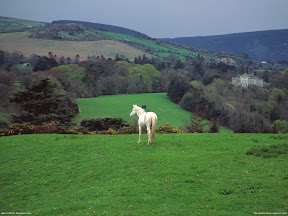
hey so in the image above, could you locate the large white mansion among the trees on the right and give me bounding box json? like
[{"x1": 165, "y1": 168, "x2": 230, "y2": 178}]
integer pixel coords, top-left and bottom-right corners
[{"x1": 232, "y1": 73, "x2": 269, "y2": 88}]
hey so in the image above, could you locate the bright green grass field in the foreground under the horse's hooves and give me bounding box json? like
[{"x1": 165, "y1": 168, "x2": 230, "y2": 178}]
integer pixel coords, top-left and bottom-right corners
[{"x1": 0, "y1": 133, "x2": 288, "y2": 216}]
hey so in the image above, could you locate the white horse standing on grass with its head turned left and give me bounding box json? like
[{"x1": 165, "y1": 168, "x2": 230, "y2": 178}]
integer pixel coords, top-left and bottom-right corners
[{"x1": 130, "y1": 104, "x2": 158, "y2": 145}]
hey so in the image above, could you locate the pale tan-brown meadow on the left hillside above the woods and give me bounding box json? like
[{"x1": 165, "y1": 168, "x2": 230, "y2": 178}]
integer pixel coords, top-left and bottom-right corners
[{"x1": 0, "y1": 32, "x2": 150, "y2": 60}]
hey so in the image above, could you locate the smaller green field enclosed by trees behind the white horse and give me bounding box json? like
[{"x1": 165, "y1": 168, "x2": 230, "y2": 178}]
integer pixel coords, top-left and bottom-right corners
[{"x1": 76, "y1": 93, "x2": 231, "y2": 132}]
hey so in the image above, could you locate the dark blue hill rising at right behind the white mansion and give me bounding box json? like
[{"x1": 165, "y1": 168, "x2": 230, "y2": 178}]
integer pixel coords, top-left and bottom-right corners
[{"x1": 160, "y1": 29, "x2": 288, "y2": 60}]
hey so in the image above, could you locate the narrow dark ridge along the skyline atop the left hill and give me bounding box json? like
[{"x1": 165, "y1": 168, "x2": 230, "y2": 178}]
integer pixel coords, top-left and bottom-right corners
[{"x1": 52, "y1": 20, "x2": 149, "y2": 38}]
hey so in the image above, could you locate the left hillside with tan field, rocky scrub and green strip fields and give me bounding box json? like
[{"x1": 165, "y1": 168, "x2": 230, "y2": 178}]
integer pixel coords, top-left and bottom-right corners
[{"x1": 0, "y1": 18, "x2": 202, "y2": 64}]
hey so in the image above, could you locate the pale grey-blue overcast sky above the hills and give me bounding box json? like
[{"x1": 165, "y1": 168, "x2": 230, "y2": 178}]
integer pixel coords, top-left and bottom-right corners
[{"x1": 0, "y1": 0, "x2": 288, "y2": 38}]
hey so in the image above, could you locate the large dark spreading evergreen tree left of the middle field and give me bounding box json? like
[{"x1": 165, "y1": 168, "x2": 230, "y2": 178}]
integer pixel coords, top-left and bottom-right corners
[{"x1": 10, "y1": 78, "x2": 78, "y2": 125}]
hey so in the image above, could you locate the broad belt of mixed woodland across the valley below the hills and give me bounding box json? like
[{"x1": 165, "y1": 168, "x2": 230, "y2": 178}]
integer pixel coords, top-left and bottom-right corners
[{"x1": 0, "y1": 51, "x2": 288, "y2": 133}]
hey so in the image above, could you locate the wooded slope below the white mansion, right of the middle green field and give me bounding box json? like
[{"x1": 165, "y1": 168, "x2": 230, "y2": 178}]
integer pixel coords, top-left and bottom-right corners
[{"x1": 167, "y1": 70, "x2": 288, "y2": 133}]
